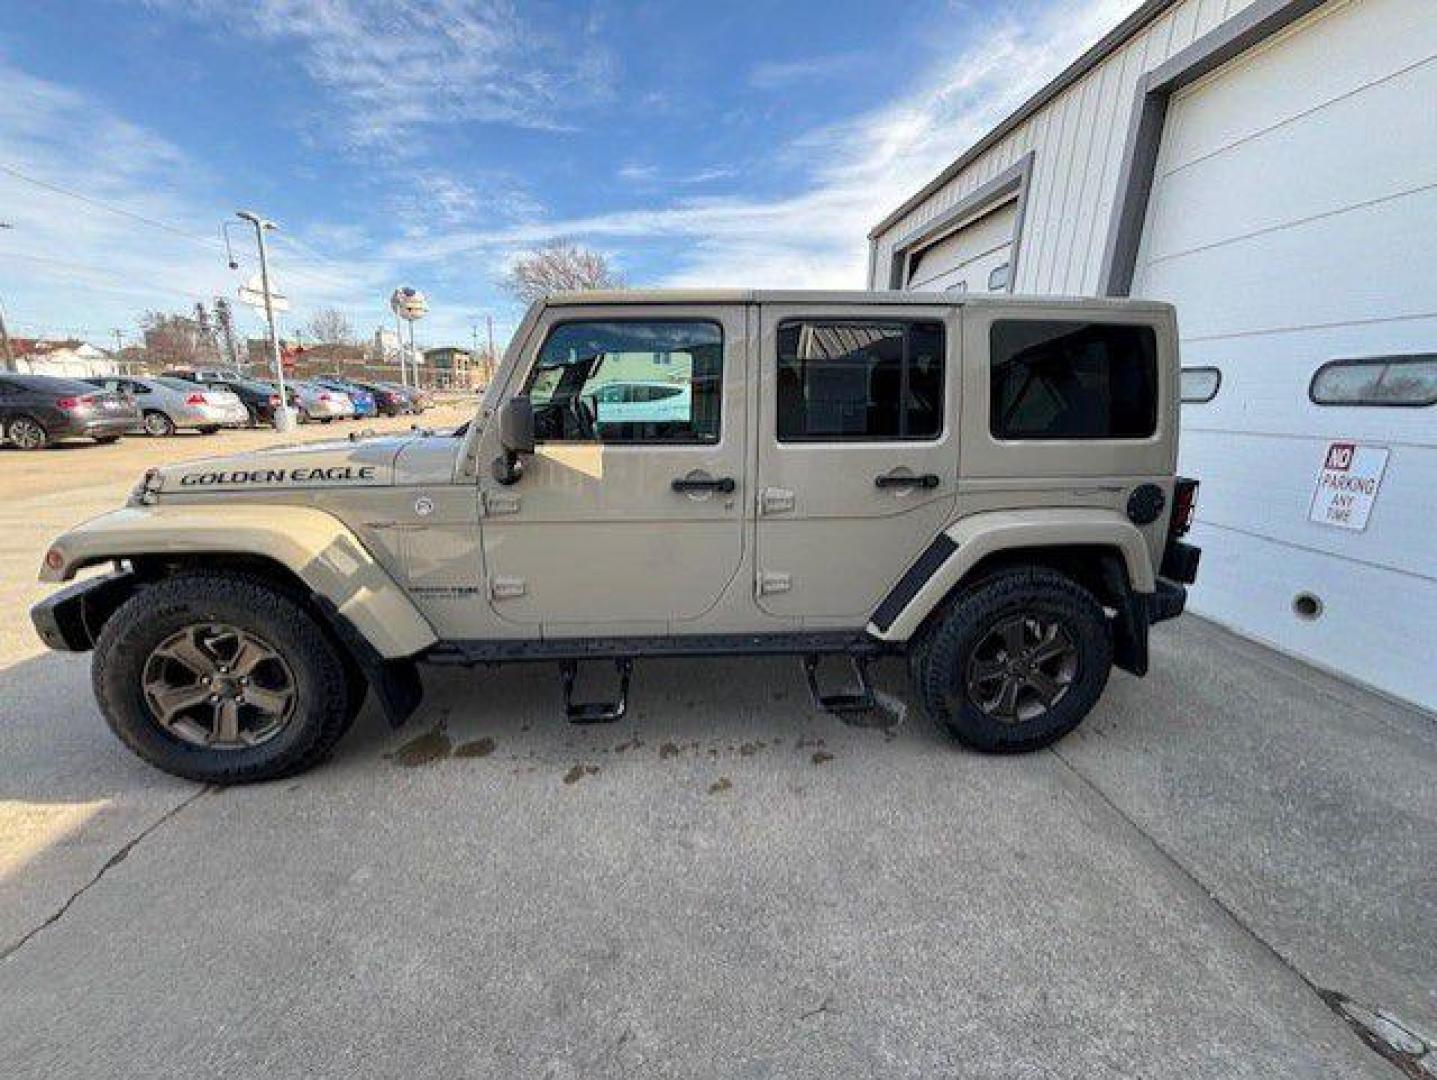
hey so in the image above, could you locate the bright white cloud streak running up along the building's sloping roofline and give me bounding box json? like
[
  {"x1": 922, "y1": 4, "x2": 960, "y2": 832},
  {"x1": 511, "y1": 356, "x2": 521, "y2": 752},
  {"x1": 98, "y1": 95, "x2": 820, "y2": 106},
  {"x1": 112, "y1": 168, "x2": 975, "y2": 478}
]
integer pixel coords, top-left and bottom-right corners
[{"x1": 387, "y1": 0, "x2": 1137, "y2": 289}]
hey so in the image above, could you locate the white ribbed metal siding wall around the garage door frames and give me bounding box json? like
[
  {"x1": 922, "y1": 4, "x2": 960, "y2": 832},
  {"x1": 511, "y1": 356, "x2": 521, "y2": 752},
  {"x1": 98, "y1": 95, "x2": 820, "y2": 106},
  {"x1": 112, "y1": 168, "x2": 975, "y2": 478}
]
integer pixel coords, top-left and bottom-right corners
[{"x1": 869, "y1": 0, "x2": 1252, "y2": 294}]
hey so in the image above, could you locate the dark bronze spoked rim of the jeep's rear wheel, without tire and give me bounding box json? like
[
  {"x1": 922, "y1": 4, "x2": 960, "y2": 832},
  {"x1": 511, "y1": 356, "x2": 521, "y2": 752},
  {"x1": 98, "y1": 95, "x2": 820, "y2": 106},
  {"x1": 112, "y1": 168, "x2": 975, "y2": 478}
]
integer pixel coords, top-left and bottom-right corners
[{"x1": 964, "y1": 615, "x2": 1078, "y2": 724}]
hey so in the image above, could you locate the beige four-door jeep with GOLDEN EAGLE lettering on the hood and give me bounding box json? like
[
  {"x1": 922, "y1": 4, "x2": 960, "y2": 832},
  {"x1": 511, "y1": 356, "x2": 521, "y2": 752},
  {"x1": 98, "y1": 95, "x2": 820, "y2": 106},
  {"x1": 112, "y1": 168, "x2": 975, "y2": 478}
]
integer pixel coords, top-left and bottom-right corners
[{"x1": 33, "y1": 292, "x2": 1198, "y2": 783}]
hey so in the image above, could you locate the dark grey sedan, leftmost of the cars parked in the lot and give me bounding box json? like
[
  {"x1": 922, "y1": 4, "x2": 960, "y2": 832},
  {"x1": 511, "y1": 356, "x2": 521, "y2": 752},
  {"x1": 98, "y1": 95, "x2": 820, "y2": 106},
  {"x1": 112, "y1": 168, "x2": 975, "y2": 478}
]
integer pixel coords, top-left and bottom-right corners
[{"x1": 0, "y1": 372, "x2": 139, "y2": 450}]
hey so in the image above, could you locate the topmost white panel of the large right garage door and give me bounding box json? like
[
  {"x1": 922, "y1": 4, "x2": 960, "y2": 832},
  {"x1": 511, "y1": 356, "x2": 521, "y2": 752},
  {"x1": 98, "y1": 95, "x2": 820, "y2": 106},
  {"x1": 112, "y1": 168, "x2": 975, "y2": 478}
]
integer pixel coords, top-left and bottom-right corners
[{"x1": 1158, "y1": 0, "x2": 1437, "y2": 171}]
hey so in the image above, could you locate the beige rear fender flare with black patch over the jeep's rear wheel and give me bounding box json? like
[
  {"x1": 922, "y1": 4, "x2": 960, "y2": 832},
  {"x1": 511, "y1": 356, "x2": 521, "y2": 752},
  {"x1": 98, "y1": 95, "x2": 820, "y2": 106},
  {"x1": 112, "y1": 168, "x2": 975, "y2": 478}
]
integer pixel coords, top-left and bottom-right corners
[{"x1": 868, "y1": 508, "x2": 1157, "y2": 642}]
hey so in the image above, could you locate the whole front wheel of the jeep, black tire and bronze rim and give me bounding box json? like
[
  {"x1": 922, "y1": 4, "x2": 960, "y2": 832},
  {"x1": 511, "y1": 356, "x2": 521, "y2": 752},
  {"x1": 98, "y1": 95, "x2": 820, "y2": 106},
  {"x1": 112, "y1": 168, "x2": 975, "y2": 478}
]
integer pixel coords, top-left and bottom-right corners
[{"x1": 92, "y1": 573, "x2": 354, "y2": 784}]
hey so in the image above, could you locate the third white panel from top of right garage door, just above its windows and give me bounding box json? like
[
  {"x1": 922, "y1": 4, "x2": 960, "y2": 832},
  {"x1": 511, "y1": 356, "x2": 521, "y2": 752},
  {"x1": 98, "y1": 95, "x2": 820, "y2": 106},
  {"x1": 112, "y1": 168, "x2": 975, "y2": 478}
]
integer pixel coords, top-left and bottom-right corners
[{"x1": 1134, "y1": 188, "x2": 1437, "y2": 339}]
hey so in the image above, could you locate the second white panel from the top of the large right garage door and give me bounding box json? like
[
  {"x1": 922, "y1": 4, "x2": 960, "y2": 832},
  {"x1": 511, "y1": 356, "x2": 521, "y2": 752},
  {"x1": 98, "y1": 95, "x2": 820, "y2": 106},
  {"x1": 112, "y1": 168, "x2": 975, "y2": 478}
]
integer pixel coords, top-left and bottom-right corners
[{"x1": 1148, "y1": 57, "x2": 1437, "y2": 260}]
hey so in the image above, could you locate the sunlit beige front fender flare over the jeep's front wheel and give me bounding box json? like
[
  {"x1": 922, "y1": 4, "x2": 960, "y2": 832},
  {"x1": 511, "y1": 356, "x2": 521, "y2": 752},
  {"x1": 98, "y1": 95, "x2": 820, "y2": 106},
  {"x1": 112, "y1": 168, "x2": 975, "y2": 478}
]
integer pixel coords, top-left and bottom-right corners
[{"x1": 40, "y1": 503, "x2": 438, "y2": 659}]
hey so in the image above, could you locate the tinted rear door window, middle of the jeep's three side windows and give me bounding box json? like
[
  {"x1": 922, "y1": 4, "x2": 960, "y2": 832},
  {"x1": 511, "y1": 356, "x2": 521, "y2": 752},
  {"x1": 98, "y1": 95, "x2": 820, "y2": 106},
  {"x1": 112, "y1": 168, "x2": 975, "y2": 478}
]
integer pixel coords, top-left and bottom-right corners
[{"x1": 777, "y1": 320, "x2": 944, "y2": 442}]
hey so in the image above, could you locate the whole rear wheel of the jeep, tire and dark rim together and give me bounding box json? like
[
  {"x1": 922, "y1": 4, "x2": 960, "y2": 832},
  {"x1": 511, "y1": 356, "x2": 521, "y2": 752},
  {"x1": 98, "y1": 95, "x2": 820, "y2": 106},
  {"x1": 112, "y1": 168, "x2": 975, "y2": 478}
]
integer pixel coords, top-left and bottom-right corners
[{"x1": 911, "y1": 567, "x2": 1112, "y2": 753}]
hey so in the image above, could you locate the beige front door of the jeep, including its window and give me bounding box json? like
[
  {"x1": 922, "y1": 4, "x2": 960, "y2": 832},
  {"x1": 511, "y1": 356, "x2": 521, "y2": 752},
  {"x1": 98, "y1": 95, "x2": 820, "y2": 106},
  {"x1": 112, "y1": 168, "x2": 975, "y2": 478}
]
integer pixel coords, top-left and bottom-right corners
[{"x1": 480, "y1": 304, "x2": 749, "y2": 638}]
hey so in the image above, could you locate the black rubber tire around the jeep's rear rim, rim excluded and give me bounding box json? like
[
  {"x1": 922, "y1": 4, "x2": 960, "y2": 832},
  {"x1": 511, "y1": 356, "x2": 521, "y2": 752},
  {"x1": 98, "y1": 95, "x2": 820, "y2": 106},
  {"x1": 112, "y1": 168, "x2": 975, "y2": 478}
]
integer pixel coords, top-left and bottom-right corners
[{"x1": 910, "y1": 567, "x2": 1112, "y2": 753}]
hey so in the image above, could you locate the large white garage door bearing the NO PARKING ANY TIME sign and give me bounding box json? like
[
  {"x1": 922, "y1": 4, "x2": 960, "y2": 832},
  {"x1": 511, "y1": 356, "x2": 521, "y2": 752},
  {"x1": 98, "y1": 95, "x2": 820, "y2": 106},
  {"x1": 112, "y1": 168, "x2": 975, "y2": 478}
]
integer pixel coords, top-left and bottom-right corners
[{"x1": 1132, "y1": 0, "x2": 1437, "y2": 708}]
